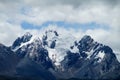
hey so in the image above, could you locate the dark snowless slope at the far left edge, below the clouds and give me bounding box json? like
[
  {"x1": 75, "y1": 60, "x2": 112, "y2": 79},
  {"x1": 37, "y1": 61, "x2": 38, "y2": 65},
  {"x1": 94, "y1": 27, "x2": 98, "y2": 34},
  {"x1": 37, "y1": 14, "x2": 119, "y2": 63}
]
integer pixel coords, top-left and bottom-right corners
[{"x1": 0, "y1": 44, "x2": 19, "y2": 75}]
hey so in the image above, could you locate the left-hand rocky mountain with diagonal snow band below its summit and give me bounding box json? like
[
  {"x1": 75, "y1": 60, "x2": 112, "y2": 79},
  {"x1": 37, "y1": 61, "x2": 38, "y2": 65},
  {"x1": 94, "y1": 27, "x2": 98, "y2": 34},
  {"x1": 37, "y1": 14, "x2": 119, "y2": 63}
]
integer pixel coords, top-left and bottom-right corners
[{"x1": 11, "y1": 33, "x2": 55, "y2": 80}]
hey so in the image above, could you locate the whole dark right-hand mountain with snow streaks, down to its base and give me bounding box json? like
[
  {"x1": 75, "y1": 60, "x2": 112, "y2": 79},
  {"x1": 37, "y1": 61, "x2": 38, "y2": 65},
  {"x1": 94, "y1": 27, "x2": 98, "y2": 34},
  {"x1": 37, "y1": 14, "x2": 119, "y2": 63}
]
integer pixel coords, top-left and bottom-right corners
[{"x1": 63, "y1": 35, "x2": 120, "y2": 79}]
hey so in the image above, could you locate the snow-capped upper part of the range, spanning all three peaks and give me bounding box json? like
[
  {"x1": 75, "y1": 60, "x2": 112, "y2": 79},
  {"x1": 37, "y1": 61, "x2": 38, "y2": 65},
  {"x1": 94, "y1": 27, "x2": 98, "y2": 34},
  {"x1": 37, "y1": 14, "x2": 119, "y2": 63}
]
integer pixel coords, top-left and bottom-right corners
[{"x1": 10, "y1": 30, "x2": 119, "y2": 72}]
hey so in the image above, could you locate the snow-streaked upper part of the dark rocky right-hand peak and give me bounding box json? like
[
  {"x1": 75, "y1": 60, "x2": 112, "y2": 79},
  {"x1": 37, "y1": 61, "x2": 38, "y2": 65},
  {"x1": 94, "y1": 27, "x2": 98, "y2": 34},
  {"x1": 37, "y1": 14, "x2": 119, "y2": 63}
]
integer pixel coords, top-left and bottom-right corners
[{"x1": 67, "y1": 35, "x2": 105, "y2": 62}]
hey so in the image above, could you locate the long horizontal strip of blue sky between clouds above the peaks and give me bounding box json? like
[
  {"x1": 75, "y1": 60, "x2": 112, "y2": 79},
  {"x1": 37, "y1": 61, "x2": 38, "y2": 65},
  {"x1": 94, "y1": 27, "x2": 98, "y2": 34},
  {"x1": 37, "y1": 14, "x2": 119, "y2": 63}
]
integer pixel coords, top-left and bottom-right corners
[{"x1": 21, "y1": 21, "x2": 108, "y2": 30}]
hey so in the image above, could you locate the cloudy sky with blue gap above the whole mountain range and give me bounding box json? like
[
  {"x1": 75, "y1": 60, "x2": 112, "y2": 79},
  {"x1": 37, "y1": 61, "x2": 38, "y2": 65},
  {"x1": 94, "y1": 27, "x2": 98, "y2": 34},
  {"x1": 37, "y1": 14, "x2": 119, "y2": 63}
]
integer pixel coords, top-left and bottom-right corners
[{"x1": 0, "y1": 0, "x2": 120, "y2": 60}]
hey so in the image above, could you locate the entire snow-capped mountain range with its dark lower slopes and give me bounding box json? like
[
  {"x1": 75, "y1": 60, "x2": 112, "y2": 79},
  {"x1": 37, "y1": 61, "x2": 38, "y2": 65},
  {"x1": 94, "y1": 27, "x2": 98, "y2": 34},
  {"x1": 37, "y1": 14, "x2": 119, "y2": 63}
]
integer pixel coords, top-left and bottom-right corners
[{"x1": 0, "y1": 30, "x2": 120, "y2": 80}]
